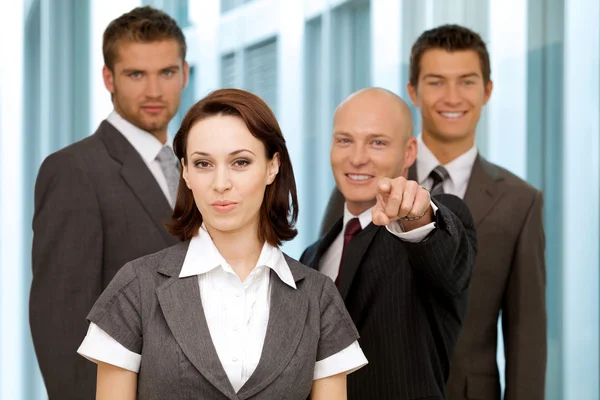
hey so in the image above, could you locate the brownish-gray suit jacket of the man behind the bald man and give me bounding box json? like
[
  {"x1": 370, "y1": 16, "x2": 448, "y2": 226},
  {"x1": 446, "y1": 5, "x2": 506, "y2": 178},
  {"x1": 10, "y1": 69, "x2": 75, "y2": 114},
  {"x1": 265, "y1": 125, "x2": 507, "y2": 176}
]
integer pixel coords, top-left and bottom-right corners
[{"x1": 322, "y1": 156, "x2": 547, "y2": 400}]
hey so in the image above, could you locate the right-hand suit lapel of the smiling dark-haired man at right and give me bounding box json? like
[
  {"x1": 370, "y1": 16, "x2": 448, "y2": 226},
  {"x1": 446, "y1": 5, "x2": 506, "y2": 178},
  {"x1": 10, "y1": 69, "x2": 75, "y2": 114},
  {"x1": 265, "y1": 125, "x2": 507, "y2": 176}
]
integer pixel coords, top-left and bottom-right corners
[{"x1": 464, "y1": 155, "x2": 502, "y2": 227}]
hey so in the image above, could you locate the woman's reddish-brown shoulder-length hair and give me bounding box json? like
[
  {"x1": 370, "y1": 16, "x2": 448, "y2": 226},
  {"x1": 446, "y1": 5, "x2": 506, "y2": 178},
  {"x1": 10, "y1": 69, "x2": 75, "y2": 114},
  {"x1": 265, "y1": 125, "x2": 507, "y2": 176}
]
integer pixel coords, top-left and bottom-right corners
[{"x1": 167, "y1": 89, "x2": 298, "y2": 246}]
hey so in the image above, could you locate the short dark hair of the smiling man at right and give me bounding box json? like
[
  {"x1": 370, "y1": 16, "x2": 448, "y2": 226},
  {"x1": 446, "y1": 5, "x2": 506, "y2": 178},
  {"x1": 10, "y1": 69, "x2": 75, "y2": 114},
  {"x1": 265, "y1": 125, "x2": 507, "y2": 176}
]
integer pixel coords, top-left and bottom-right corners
[{"x1": 409, "y1": 25, "x2": 491, "y2": 87}]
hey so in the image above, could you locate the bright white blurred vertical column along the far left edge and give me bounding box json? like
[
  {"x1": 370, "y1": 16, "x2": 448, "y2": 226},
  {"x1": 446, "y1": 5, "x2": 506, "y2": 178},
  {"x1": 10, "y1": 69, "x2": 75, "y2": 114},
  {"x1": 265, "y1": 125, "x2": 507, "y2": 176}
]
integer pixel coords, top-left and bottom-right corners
[{"x1": 0, "y1": 1, "x2": 29, "y2": 399}]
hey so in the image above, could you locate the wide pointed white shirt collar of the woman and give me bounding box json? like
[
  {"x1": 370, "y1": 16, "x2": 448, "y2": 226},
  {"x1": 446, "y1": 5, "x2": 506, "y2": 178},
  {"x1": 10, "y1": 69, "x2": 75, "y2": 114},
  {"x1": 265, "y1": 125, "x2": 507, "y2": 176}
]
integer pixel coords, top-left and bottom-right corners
[{"x1": 179, "y1": 224, "x2": 296, "y2": 289}]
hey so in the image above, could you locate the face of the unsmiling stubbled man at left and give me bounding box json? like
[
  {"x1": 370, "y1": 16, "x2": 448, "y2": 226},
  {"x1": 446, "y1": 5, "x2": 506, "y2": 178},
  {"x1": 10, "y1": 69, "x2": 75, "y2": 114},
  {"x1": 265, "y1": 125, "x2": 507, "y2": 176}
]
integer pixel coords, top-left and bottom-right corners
[{"x1": 102, "y1": 39, "x2": 189, "y2": 143}]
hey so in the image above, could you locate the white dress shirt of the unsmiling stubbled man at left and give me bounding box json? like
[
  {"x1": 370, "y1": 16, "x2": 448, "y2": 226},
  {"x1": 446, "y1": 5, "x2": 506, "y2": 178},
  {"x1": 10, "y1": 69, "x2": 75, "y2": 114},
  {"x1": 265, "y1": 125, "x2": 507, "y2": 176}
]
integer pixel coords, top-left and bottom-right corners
[{"x1": 106, "y1": 111, "x2": 175, "y2": 207}]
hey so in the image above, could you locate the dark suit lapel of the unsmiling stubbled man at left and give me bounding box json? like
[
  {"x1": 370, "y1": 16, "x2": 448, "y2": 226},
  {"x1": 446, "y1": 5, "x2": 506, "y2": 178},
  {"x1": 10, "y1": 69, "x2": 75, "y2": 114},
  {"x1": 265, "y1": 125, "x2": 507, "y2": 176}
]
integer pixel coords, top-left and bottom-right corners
[{"x1": 98, "y1": 121, "x2": 176, "y2": 244}]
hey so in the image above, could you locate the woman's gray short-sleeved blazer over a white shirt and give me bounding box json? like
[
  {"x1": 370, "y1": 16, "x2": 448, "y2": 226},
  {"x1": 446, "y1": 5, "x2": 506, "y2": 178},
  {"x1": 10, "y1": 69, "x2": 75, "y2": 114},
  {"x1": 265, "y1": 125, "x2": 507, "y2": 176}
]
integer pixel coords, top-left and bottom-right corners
[{"x1": 88, "y1": 241, "x2": 358, "y2": 400}]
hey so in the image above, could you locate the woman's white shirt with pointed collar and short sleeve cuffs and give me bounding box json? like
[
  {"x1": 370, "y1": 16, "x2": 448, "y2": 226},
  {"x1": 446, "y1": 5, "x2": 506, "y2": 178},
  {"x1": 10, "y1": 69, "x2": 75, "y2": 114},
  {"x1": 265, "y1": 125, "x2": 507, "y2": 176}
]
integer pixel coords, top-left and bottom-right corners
[{"x1": 77, "y1": 227, "x2": 367, "y2": 392}]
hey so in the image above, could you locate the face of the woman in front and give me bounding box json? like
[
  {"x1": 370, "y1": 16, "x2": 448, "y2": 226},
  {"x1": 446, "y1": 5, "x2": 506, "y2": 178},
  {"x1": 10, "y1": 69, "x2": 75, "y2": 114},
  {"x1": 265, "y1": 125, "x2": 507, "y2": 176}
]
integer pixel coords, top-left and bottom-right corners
[{"x1": 182, "y1": 115, "x2": 279, "y2": 233}]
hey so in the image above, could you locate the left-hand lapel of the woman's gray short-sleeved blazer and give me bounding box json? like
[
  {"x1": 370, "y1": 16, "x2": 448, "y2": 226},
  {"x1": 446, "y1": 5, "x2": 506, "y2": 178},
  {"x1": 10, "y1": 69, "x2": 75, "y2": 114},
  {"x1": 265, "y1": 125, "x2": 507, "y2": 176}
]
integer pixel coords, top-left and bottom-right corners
[{"x1": 156, "y1": 242, "x2": 237, "y2": 399}]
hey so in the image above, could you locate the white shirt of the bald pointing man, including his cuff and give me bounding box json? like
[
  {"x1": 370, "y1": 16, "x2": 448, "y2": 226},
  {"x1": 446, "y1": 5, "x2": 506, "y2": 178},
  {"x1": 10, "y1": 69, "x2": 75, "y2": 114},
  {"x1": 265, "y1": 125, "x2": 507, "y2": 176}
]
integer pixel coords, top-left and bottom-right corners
[{"x1": 319, "y1": 202, "x2": 438, "y2": 282}]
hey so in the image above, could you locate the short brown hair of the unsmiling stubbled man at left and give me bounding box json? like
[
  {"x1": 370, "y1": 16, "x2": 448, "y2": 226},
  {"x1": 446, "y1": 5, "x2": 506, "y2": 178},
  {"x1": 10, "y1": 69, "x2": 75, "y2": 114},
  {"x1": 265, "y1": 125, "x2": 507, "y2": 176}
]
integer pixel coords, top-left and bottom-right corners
[{"x1": 102, "y1": 6, "x2": 187, "y2": 72}]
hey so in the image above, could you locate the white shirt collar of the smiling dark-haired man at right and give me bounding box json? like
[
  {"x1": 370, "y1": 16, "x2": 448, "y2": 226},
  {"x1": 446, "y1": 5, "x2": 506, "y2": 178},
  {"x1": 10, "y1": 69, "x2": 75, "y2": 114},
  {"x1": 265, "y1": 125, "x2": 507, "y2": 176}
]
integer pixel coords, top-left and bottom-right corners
[{"x1": 417, "y1": 135, "x2": 477, "y2": 185}]
